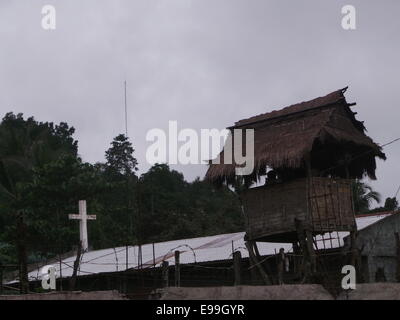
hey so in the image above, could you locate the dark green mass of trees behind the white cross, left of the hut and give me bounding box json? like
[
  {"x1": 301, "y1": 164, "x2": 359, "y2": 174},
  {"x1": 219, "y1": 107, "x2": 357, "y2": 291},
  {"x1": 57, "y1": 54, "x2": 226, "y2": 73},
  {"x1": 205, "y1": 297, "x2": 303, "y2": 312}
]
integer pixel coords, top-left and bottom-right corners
[{"x1": 0, "y1": 113, "x2": 243, "y2": 274}]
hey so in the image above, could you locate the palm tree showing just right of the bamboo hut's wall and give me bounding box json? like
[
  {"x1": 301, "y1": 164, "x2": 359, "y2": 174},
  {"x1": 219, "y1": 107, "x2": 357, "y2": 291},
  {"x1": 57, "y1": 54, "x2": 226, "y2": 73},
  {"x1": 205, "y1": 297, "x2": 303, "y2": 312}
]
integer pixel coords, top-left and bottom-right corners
[{"x1": 352, "y1": 180, "x2": 381, "y2": 214}]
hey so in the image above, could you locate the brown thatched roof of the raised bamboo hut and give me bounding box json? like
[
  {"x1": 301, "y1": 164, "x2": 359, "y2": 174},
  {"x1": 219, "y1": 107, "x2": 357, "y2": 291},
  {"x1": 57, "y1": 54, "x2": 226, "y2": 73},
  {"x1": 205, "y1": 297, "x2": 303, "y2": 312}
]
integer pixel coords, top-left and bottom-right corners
[{"x1": 206, "y1": 87, "x2": 385, "y2": 182}]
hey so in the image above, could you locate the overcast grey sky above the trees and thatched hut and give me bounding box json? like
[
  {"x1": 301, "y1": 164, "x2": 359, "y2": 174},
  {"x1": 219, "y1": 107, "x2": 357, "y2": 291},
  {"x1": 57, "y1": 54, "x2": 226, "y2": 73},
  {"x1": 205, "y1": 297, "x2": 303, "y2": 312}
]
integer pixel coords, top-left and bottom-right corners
[{"x1": 0, "y1": 0, "x2": 400, "y2": 202}]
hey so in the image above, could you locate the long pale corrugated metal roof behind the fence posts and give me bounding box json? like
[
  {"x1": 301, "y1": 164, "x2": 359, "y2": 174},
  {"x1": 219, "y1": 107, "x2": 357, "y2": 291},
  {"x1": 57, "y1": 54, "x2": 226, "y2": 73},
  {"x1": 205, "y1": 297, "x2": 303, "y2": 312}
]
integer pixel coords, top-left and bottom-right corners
[{"x1": 18, "y1": 213, "x2": 391, "y2": 280}]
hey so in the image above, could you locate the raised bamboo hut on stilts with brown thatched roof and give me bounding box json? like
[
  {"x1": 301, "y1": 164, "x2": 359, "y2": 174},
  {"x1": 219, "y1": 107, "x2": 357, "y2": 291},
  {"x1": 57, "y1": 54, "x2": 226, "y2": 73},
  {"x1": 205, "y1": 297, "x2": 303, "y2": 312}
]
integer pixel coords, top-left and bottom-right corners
[{"x1": 206, "y1": 87, "x2": 385, "y2": 282}]
